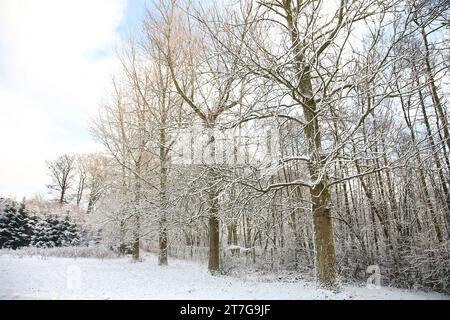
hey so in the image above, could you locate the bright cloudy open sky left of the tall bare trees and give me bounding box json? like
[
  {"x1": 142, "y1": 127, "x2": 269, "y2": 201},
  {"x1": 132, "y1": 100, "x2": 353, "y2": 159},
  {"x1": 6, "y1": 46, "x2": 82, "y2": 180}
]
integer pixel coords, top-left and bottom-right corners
[{"x1": 0, "y1": 0, "x2": 145, "y2": 199}]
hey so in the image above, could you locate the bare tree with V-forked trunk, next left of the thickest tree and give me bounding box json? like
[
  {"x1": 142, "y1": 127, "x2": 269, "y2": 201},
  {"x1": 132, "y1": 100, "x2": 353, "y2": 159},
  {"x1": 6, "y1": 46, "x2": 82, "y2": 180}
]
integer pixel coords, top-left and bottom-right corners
[{"x1": 145, "y1": 2, "x2": 250, "y2": 272}]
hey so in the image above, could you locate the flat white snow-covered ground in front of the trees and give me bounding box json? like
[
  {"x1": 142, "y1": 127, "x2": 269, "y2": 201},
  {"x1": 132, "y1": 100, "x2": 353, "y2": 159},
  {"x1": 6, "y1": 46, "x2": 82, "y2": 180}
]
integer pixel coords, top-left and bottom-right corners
[{"x1": 0, "y1": 253, "x2": 450, "y2": 300}]
